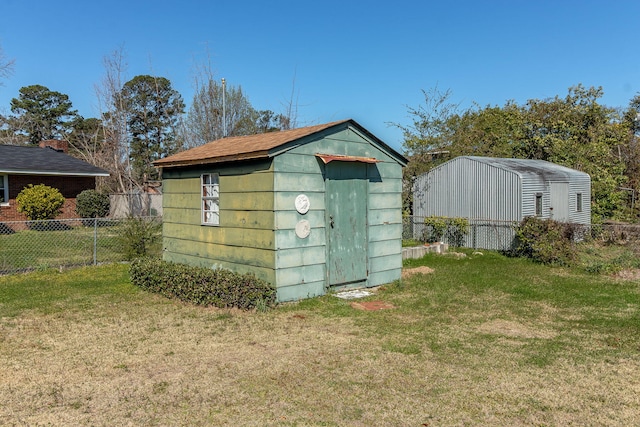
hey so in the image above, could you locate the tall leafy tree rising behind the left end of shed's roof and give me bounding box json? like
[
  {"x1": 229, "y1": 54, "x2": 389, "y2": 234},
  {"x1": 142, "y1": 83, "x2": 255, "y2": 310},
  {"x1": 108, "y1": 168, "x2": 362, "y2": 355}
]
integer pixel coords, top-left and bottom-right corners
[{"x1": 122, "y1": 75, "x2": 185, "y2": 184}]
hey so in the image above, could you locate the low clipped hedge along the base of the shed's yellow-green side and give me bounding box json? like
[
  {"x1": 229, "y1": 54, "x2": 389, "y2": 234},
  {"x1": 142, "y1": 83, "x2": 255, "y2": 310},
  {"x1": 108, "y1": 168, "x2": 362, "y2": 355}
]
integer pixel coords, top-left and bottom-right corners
[{"x1": 130, "y1": 258, "x2": 276, "y2": 310}]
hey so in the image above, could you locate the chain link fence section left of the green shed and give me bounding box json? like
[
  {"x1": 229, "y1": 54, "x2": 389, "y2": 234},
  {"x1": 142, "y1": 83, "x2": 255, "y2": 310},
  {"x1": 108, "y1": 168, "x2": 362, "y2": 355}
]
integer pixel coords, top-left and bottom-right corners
[{"x1": 0, "y1": 217, "x2": 162, "y2": 274}]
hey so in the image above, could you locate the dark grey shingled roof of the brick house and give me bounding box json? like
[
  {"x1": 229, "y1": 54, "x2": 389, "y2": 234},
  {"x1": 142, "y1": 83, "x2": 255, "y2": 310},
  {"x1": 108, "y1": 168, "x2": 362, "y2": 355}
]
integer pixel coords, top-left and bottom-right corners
[{"x1": 0, "y1": 145, "x2": 109, "y2": 176}]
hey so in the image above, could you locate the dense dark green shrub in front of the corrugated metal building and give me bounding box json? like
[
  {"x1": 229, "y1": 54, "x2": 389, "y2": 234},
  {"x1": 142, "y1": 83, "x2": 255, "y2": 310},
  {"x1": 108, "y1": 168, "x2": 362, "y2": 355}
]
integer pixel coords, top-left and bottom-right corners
[{"x1": 512, "y1": 217, "x2": 577, "y2": 265}]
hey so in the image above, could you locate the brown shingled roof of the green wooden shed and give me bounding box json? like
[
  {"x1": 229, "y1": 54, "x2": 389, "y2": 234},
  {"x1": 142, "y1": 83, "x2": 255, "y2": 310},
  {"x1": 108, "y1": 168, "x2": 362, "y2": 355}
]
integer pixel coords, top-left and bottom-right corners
[{"x1": 153, "y1": 119, "x2": 407, "y2": 167}]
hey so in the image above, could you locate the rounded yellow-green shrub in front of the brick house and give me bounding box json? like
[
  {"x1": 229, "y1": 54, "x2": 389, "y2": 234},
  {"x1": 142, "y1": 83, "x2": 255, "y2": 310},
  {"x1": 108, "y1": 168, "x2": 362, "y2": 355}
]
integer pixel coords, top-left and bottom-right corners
[{"x1": 16, "y1": 184, "x2": 64, "y2": 221}]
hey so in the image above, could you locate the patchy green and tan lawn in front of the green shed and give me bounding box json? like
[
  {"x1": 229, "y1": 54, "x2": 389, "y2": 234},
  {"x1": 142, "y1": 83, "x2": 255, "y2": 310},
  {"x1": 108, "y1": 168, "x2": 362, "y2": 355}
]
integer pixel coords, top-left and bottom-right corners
[{"x1": 0, "y1": 252, "x2": 640, "y2": 426}]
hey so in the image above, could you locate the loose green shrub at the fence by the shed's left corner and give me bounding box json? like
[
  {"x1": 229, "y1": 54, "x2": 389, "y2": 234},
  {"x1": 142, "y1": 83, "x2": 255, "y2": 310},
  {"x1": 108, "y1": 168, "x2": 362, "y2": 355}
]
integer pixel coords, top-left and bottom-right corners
[{"x1": 118, "y1": 217, "x2": 162, "y2": 261}]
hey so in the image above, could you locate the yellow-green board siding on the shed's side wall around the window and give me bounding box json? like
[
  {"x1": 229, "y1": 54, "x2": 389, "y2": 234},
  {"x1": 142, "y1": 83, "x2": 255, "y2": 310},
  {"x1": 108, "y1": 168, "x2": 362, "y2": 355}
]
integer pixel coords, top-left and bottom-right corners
[{"x1": 163, "y1": 161, "x2": 276, "y2": 283}]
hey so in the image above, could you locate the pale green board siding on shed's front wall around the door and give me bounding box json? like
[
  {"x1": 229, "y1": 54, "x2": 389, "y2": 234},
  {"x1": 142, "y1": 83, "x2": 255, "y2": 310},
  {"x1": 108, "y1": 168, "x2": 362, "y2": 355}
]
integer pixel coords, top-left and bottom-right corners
[{"x1": 273, "y1": 128, "x2": 402, "y2": 300}]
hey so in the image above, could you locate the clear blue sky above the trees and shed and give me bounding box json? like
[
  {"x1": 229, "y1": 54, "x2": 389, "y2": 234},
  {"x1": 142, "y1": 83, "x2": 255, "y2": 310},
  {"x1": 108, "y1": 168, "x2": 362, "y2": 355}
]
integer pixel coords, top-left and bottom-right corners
[{"x1": 0, "y1": 0, "x2": 640, "y2": 154}]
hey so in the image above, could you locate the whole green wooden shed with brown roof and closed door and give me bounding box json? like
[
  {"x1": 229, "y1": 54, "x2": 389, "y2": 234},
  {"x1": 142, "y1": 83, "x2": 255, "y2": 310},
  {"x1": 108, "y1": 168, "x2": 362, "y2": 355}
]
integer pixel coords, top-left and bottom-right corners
[{"x1": 154, "y1": 120, "x2": 407, "y2": 301}]
